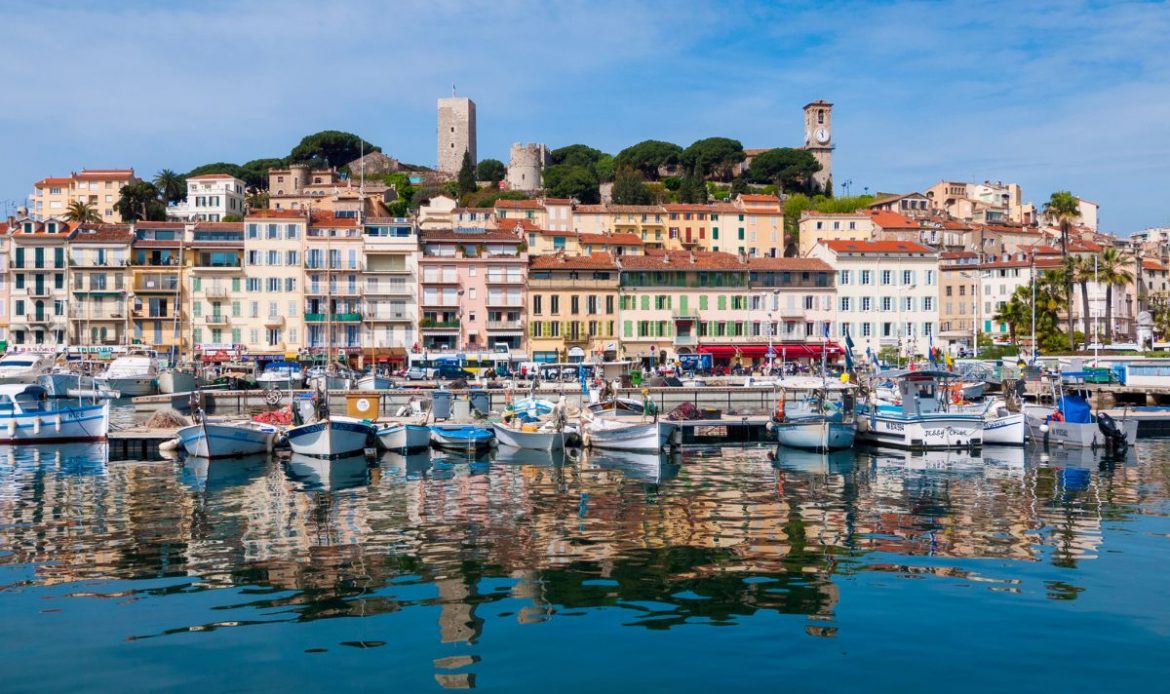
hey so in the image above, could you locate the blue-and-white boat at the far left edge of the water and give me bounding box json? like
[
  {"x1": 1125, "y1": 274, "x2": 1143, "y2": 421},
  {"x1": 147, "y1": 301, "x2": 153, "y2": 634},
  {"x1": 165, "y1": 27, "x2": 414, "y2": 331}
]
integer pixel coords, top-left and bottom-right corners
[{"x1": 0, "y1": 383, "x2": 110, "y2": 444}]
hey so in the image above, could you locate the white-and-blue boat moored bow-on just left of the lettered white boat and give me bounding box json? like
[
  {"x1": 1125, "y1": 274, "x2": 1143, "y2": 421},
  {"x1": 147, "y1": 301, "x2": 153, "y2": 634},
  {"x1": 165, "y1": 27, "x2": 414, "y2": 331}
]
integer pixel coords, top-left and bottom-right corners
[{"x1": 771, "y1": 378, "x2": 858, "y2": 451}]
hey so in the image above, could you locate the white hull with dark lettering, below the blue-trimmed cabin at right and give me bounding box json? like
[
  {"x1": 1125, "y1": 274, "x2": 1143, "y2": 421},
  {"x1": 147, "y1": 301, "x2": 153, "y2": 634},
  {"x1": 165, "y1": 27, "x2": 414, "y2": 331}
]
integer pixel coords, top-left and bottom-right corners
[{"x1": 858, "y1": 412, "x2": 983, "y2": 451}]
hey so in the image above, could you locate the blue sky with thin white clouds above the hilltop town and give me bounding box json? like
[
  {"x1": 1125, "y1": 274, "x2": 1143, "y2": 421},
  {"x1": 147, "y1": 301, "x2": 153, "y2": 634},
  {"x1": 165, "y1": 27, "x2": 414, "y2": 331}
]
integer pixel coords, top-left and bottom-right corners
[{"x1": 0, "y1": 0, "x2": 1170, "y2": 234}]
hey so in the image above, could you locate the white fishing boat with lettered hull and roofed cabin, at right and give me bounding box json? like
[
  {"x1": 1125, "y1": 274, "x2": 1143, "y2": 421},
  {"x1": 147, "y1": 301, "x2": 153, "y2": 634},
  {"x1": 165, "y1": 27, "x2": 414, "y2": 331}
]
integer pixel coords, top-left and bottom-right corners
[{"x1": 858, "y1": 370, "x2": 983, "y2": 451}]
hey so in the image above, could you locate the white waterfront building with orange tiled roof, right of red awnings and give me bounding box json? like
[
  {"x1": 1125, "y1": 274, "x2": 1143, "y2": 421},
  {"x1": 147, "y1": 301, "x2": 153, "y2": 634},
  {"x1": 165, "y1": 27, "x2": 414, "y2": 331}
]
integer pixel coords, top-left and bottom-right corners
[{"x1": 810, "y1": 241, "x2": 938, "y2": 356}]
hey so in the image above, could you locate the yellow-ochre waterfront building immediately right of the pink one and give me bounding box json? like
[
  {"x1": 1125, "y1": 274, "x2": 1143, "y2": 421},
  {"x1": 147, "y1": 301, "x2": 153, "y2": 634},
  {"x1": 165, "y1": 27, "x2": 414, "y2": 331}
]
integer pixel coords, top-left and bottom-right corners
[{"x1": 528, "y1": 253, "x2": 618, "y2": 362}]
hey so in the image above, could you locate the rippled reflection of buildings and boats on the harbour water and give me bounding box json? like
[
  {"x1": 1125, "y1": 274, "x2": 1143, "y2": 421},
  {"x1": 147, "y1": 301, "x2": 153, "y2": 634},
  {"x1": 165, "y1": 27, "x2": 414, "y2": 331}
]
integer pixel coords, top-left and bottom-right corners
[{"x1": 0, "y1": 442, "x2": 1170, "y2": 664}]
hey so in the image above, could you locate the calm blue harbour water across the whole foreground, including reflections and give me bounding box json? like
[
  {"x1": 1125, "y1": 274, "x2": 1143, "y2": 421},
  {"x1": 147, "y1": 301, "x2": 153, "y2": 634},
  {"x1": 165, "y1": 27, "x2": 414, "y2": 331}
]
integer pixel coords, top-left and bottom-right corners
[{"x1": 0, "y1": 440, "x2": 1170, "y2": 693}]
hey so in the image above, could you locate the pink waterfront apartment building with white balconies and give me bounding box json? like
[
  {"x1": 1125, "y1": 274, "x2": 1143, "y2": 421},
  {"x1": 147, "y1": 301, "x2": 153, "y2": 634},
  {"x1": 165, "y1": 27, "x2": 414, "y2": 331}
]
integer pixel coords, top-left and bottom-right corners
[{"x1": 419, "y1": 229, "x2": 528, "y2": 353}]
